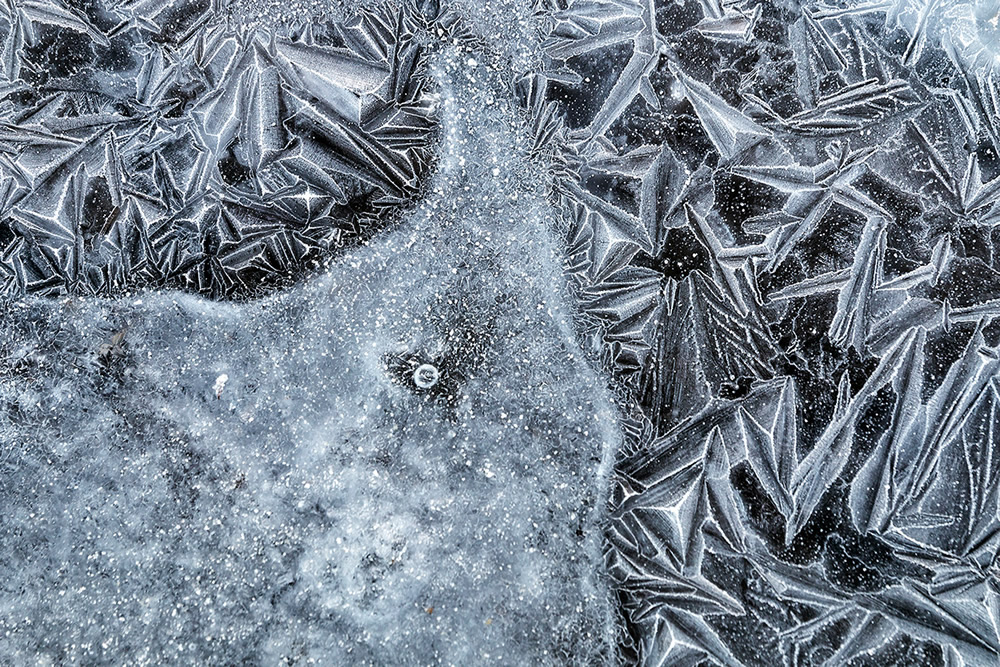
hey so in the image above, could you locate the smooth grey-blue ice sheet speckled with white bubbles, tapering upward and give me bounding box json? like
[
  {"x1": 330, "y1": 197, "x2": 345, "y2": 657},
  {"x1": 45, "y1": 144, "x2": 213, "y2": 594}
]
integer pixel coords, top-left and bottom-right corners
[{"x1": 0, "y1": 49, "x2": 618, "y2": 665}]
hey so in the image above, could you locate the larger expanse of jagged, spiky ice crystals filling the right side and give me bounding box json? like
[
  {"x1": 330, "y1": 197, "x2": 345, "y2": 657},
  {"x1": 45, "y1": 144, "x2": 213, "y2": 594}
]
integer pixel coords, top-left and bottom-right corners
[{"x1": 544, "y1": 0, "x2": 1000, "y2": 666}]
